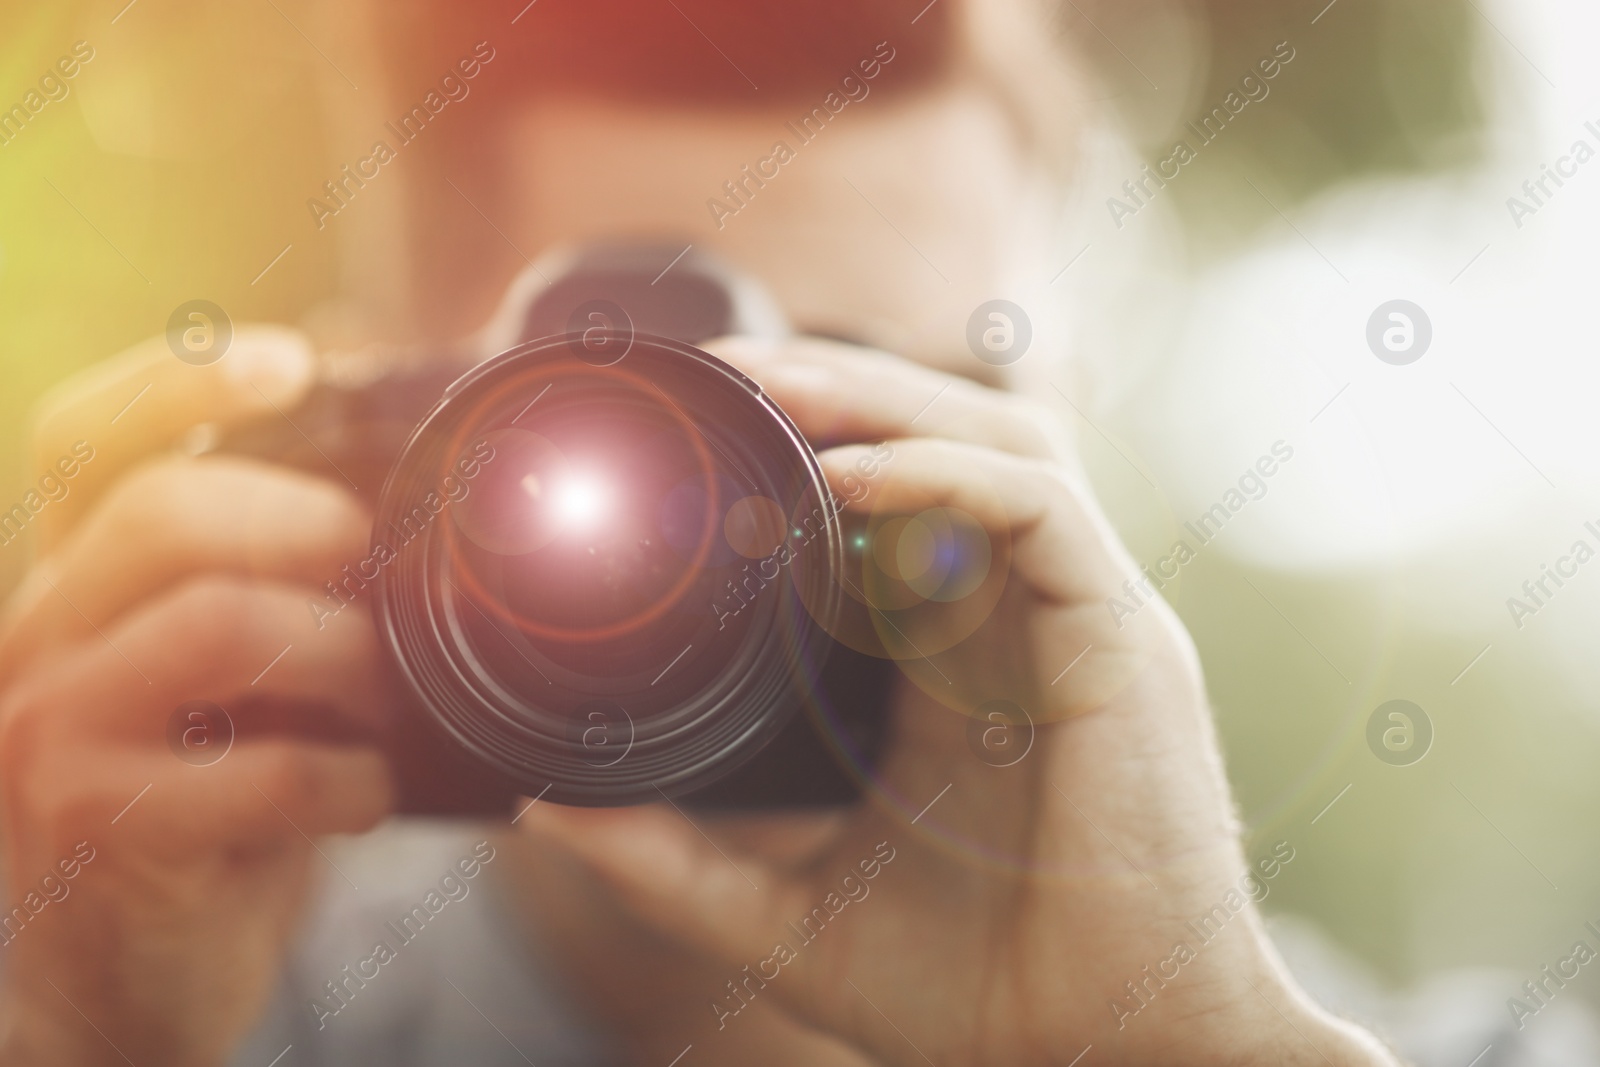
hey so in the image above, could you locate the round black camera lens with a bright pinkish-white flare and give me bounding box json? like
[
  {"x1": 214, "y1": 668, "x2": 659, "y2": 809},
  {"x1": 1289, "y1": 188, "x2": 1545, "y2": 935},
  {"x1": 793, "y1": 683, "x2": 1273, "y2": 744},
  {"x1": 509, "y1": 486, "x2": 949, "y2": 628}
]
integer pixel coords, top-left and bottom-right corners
[{"x1": 373, "y1": 337, "x2": 843, "y2": 805}]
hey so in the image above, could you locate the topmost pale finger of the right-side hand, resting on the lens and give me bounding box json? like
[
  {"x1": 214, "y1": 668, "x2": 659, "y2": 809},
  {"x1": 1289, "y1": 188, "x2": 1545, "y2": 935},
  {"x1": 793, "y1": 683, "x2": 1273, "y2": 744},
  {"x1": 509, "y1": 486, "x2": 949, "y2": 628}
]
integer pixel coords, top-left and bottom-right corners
[{"x1": 707, "y1": 338, "x2": 1067, "y2": 459}]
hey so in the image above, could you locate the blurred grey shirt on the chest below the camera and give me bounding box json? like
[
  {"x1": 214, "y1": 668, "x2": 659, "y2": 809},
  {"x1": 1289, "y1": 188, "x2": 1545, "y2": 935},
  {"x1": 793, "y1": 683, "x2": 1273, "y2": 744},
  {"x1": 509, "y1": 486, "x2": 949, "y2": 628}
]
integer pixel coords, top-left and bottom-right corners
[{"x1": 234, "y1": 821, "x2": 621, "y2": 1067}]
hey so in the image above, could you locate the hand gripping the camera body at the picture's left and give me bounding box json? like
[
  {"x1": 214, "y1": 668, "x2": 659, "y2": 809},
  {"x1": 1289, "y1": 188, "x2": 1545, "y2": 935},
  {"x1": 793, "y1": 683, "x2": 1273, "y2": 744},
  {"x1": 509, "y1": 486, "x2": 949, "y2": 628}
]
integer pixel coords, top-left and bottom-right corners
[{"x1": 0, "y1": 328, "x2": 394, "y2": 1067}]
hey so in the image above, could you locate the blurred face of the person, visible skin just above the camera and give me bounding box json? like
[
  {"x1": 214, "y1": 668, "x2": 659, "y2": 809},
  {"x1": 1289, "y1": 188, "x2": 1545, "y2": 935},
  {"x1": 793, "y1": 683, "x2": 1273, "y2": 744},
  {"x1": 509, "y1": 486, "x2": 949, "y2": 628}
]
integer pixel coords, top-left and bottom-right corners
[{"x1": 512, "y1": 89, "x2": 1059, "y2": 383}]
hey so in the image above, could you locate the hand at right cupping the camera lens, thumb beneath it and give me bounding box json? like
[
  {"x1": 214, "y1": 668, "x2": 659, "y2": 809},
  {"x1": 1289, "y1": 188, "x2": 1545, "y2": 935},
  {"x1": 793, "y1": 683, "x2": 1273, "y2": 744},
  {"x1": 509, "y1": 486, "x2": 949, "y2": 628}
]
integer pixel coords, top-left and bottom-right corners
[{"x1": 522, "y1": 341, "x2": 1392, "y2": 1067}]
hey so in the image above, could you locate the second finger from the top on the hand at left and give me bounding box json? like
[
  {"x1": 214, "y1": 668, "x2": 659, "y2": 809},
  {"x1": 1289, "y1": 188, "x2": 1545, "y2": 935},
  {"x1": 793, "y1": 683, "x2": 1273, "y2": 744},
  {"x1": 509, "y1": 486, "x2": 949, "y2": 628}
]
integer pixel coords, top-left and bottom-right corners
[{"x1": 0, "y1": 456, "x2": 370, "y2": 654}]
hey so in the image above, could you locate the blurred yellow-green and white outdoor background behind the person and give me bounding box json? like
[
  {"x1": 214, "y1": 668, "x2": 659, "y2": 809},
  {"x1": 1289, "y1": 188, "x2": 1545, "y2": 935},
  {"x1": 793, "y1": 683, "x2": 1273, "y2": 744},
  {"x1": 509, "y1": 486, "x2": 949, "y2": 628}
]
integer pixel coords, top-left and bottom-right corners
[{"x1": 0, "y1": 0, "x2": 1600, "y2": 1064}]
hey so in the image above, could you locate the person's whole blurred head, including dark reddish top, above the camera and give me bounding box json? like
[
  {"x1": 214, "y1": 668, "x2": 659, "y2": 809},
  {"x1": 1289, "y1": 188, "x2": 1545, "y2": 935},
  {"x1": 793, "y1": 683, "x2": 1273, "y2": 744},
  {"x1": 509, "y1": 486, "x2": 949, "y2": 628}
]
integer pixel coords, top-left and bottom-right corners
[{"x1": 388, "y1": 0, "x2": 1061, "y2": 374}]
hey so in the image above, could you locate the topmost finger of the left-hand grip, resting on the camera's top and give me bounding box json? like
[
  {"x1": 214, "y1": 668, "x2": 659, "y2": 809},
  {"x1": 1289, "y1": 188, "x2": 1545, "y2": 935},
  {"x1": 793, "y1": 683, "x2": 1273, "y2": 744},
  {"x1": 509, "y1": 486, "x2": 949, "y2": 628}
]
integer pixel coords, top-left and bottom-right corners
[{"x1": 32, "y1": 326, "x2": 315, "y2": 545}]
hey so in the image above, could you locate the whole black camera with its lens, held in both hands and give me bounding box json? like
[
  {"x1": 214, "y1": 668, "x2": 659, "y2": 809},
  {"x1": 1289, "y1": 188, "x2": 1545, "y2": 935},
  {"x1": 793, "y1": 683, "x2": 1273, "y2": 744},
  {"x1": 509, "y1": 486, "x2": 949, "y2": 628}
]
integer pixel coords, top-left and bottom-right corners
[{"x1": 218, "y1": 243, "x2": 896, "y2": 816}]
